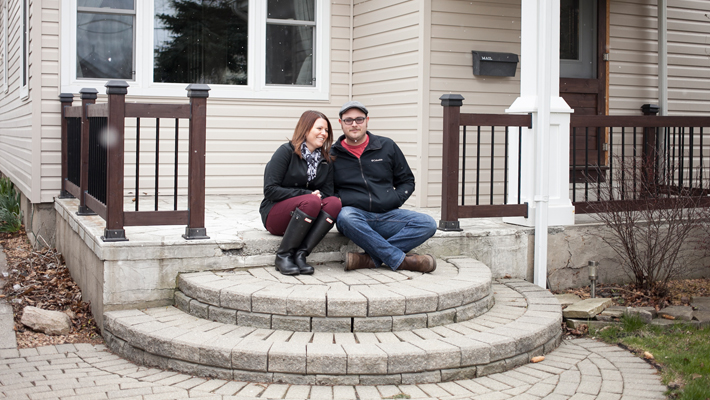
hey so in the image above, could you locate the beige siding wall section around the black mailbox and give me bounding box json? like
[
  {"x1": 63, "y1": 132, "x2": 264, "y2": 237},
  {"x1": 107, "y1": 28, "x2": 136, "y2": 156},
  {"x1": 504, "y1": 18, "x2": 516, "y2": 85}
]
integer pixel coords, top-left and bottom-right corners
[{"x1": 426, "y1": 0, "x2": 520, "y2": 207}]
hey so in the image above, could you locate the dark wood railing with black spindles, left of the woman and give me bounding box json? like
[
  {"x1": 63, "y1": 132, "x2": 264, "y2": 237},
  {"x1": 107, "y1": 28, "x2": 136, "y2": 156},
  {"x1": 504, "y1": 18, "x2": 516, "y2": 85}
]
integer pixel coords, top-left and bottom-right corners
[{"x1": 60, "y1": 81, "x2": 210, "y2": 241}]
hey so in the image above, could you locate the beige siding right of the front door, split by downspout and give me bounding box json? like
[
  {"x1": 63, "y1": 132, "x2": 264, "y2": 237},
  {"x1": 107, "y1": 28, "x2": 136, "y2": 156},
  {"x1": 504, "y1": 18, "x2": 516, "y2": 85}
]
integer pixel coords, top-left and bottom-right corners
[{"x1": 609, "y1": 0, "x2": 710, "y2": 115}]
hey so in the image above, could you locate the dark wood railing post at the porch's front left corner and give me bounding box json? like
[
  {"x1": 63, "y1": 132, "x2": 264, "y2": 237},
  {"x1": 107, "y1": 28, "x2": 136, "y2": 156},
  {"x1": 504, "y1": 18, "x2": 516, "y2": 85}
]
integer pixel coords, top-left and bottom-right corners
[{"x1": 101, "y1": 81, "x2": 128, "y2": 242}]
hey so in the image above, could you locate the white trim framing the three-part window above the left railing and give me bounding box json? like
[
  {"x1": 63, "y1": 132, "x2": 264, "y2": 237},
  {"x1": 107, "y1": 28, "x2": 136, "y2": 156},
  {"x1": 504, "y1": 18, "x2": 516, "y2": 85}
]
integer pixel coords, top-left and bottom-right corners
[{"x1": 60, "y1": 0, "x2": 330, "y2": 100}]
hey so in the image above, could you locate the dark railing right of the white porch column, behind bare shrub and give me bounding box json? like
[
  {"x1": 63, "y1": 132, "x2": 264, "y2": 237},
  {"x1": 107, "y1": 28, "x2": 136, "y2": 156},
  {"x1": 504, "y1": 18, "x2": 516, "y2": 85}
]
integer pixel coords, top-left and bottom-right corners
[{"x1": 570, "y1": 105, "x2": 710, "y2": 214}]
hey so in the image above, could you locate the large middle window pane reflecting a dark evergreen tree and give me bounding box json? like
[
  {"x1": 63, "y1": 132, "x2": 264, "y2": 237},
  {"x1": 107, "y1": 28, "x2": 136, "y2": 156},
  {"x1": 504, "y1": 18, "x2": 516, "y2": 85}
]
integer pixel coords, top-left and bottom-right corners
[{"x1": 153, "y1": 0, "x2": 249, "y2": 85}]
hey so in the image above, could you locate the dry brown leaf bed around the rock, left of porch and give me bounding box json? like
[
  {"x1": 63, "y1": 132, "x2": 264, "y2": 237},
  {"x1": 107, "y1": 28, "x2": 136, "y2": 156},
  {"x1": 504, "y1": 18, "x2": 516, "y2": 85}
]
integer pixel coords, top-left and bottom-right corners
[{"x1": 0, "y1": 231, "x2": 103, "y2": 348}]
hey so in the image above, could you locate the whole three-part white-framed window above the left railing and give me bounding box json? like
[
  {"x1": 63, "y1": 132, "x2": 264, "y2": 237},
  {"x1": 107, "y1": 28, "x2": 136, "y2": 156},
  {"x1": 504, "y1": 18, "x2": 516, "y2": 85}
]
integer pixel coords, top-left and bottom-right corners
[{"x1": 61, "y1": 0, "x2": 330, "y2": 100}]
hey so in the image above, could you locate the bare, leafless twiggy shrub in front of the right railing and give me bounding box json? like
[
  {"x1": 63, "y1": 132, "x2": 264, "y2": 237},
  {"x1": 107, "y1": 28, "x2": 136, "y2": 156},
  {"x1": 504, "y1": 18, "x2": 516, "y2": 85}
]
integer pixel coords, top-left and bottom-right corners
[{"x1": 590, "y1": 156, "x2": 705, "y2": 297}]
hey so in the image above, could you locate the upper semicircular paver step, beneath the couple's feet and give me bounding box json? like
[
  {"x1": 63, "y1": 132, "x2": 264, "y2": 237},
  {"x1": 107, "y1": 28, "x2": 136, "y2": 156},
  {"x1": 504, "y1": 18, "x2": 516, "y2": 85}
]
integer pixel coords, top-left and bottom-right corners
[{"x1": 175, "y1": 258, "x2": 493, "y2": 332}]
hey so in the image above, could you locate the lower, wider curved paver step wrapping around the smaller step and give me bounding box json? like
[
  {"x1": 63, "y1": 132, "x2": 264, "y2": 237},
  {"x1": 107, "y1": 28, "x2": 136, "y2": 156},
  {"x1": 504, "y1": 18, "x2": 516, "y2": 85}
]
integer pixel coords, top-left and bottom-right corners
[{"x1": 104, "y1": 280, "x2": 562, "y2": 385}]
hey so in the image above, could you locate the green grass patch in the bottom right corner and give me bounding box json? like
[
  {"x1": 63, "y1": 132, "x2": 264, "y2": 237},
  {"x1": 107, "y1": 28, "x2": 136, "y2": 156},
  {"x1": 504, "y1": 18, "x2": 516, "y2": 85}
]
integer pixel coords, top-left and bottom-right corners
[{"x1": 590, "y1": 317, "x2": 710, "y2": 400}]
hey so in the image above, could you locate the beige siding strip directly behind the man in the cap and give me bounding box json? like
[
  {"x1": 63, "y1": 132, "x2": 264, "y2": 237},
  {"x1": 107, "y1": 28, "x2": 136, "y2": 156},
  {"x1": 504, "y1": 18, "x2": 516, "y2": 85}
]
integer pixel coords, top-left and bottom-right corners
[{"x1": 352, "y1": 0, "x2": 423, "y2": 204}]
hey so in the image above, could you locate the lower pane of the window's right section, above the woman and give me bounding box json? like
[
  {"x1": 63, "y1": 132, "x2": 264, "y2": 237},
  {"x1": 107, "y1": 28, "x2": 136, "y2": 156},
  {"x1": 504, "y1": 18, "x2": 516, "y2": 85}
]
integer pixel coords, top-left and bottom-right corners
[{"x1": 266, "y1": 25, "x2": 315, "y2": 86}]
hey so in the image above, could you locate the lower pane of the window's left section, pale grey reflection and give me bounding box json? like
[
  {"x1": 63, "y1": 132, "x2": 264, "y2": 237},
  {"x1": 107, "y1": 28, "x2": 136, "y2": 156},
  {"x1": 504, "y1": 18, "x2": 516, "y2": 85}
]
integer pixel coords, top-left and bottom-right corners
[{"x1": 76, "y1": 13, "x2": 133, "y2": 79}]
